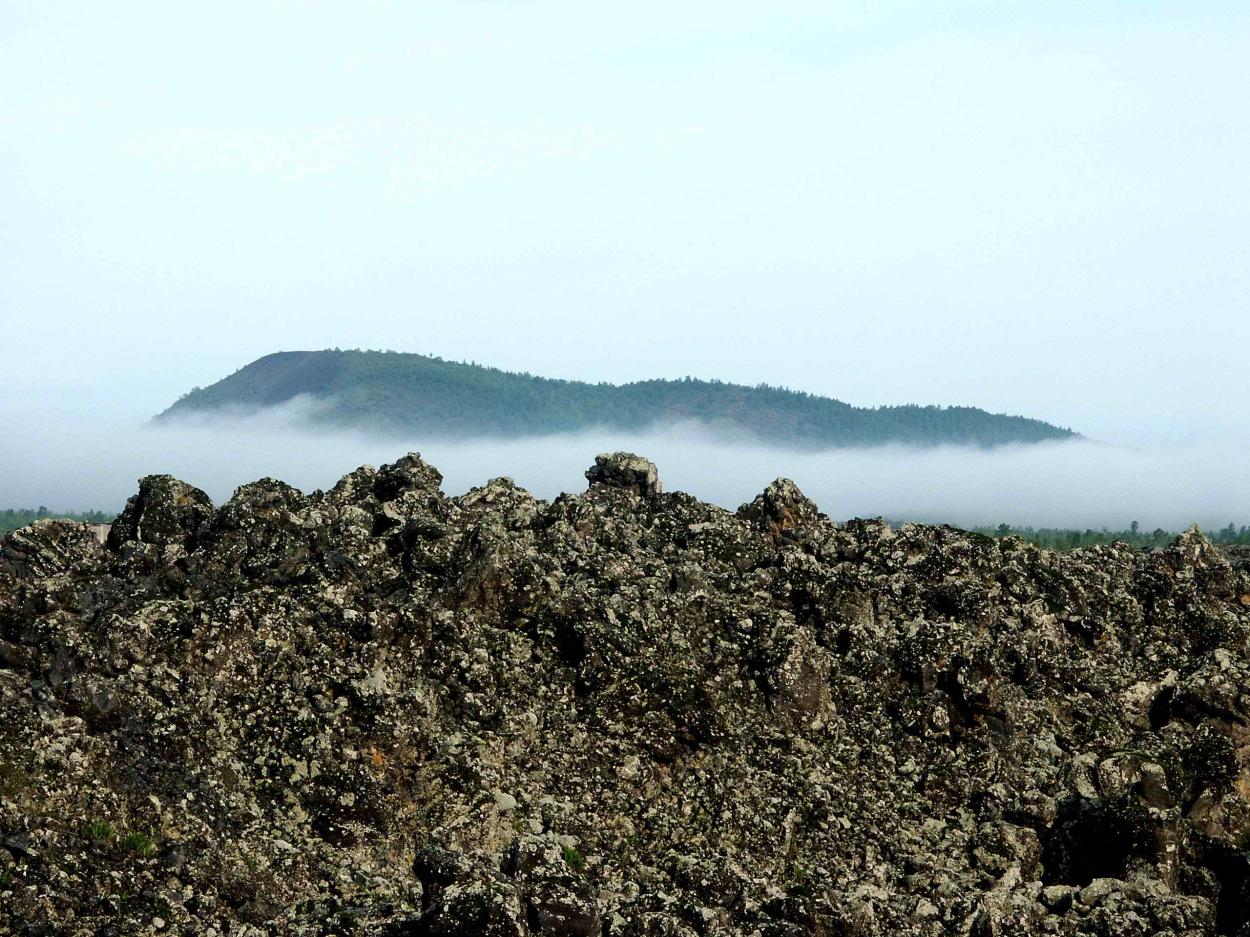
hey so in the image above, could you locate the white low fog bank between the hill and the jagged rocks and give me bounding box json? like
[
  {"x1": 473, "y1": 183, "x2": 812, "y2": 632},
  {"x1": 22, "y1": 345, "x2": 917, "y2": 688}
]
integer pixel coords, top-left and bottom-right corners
[{"x1": 0, "y1": 411, "x2": 1250, "y2": 530}]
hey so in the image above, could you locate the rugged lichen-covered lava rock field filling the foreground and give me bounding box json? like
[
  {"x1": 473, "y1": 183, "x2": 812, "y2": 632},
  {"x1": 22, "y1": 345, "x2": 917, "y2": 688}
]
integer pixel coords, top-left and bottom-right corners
[{"x1": 0, "y1": 454, "x2": 1250, "y2": 937}]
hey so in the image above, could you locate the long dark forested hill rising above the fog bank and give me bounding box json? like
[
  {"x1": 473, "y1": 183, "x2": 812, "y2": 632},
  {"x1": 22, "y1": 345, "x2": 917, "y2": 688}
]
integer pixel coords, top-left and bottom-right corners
[{"x1": 156, "y1": 350, "x2": 1075, "y2": 449}]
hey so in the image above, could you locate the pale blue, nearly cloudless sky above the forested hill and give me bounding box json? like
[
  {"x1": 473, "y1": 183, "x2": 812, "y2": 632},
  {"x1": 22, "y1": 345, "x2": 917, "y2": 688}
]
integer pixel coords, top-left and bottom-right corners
[{"x1": 0, "y1": 0, "x2": 1250, "y2": 451}]
